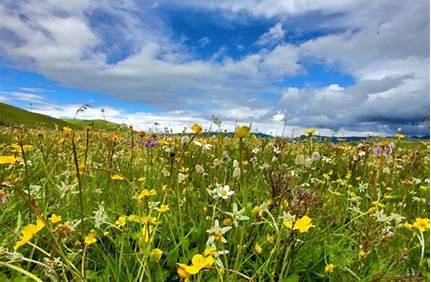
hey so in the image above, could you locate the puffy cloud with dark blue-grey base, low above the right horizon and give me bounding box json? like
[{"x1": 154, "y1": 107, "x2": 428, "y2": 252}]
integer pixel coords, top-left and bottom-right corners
[{"x1": 281, "y1": 72, "x2": 430, "y2": 134}]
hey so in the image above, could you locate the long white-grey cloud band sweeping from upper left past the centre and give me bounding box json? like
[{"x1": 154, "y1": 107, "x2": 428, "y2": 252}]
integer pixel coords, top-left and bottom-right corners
[{"x1": 0, "y1": 1, "x2": 301, "y2": 108}]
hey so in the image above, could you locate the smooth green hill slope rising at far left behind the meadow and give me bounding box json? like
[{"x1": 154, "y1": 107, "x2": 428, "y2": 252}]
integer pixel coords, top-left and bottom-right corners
[{"x1": 0, "y1": 103, "x2": 70, "y2": 128}]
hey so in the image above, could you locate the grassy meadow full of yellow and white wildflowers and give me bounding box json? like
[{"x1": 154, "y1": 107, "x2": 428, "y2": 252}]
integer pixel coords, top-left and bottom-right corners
[{"x1": 0, "y1": 124, "x2": 430, "y2": 282}]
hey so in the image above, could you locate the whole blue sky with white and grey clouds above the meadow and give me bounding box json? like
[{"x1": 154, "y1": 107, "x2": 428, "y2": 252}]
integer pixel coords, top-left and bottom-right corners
[{"x1": 0, "y1": 0, "x2": 430, "y2": 136}]
